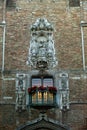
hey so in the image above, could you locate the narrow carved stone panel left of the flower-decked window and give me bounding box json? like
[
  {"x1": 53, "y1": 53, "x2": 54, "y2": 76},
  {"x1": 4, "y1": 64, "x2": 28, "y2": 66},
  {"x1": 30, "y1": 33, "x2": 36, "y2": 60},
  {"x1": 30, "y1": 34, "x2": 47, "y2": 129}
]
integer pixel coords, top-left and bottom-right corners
[{"x1": 15, "y1": 74, "x2": 26, "y2": 112}]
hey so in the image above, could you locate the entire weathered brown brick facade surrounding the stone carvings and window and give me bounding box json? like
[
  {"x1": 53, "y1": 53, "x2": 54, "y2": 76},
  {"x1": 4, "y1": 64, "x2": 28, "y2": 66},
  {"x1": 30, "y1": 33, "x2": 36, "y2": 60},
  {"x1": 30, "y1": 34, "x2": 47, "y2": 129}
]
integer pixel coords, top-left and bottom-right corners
[{"x1": 0, "y1": 0, "x2": 87, "y2": 130}]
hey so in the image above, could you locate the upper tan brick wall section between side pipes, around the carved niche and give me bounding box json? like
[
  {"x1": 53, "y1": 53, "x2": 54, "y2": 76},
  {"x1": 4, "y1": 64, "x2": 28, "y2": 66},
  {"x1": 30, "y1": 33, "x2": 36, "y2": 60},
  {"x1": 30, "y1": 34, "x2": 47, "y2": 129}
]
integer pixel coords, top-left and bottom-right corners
[{"x1": 5, "y1": 1, "x2": 82, "y2": 69}]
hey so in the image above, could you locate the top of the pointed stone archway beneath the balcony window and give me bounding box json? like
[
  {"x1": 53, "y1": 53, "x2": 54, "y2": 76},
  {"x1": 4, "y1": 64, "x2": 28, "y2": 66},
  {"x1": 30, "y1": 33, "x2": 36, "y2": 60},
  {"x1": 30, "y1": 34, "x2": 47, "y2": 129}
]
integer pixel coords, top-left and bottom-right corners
[{"x1": 17, "y1": 117, "x2": 70, "y2": 130}]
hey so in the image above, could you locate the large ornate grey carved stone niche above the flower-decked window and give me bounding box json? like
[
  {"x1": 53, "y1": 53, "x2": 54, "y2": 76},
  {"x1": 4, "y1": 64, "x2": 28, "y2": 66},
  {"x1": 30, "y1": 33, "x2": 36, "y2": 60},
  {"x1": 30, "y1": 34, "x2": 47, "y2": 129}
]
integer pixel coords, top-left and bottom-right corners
[{"x1": 28, "y1": 18, "x2": 57, "y2": 69}]
